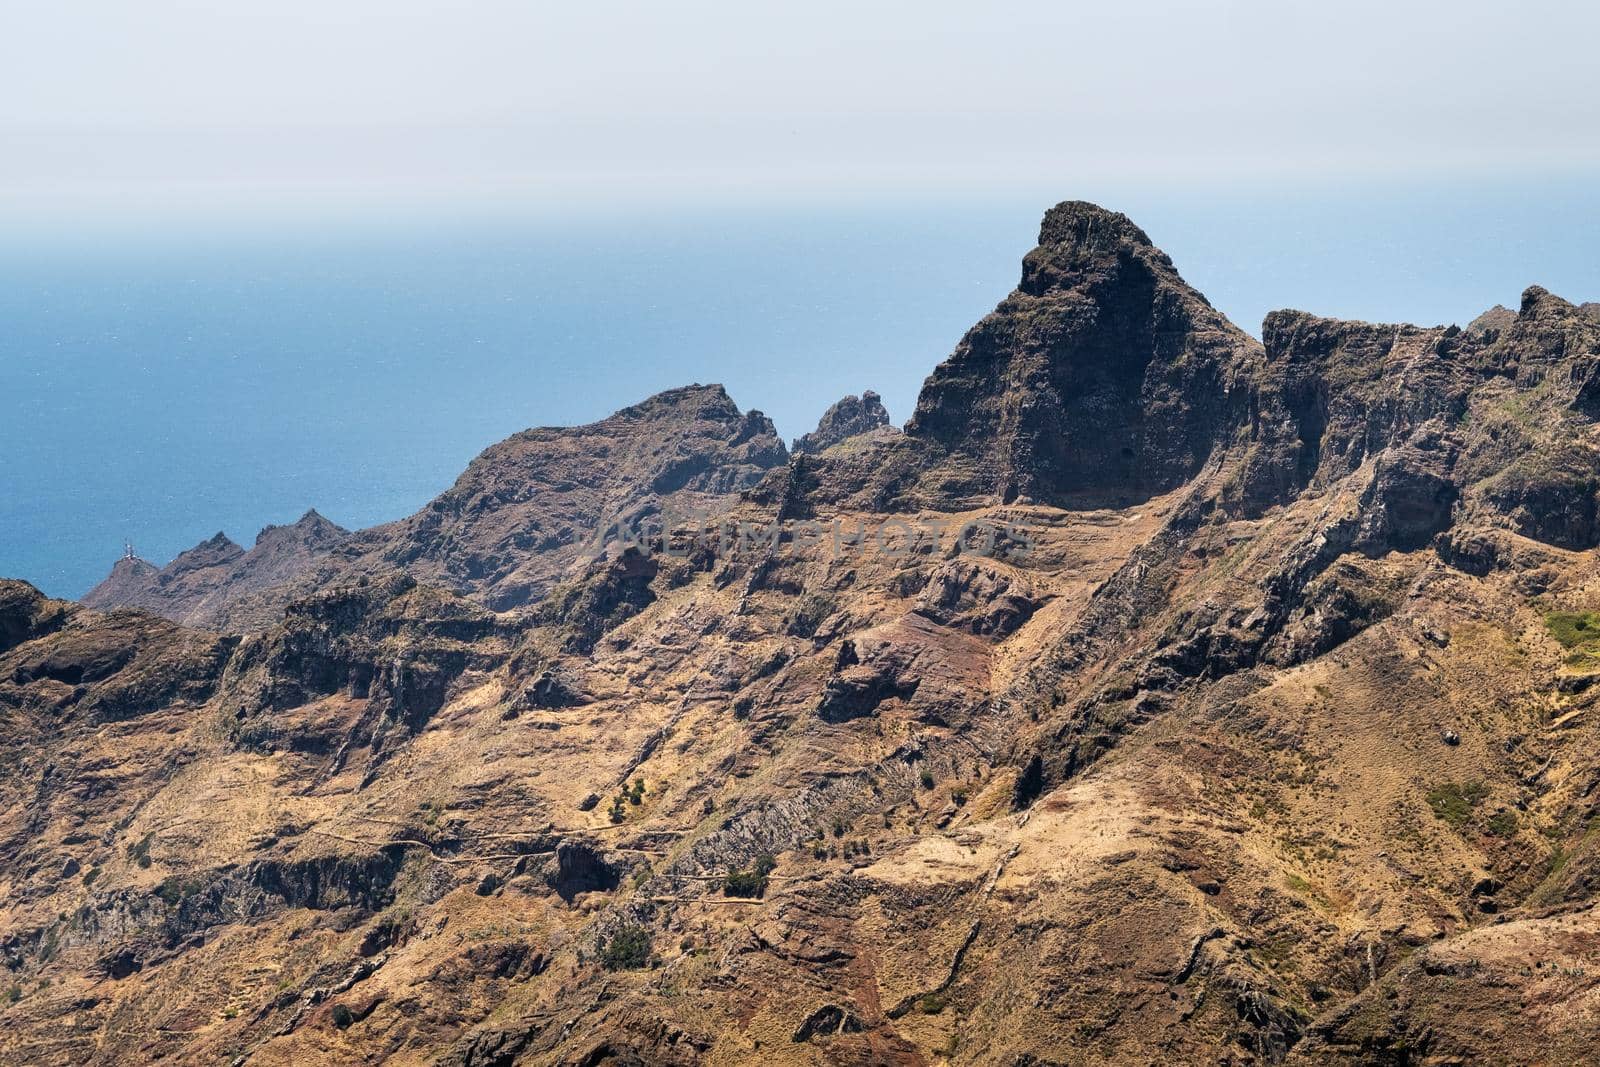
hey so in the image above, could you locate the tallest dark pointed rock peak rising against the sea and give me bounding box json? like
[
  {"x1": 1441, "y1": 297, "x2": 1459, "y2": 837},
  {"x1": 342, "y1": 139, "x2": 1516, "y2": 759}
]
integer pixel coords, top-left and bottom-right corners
[{"x1": 906, "y1": 202, "x2": 1259, "y2": 506}]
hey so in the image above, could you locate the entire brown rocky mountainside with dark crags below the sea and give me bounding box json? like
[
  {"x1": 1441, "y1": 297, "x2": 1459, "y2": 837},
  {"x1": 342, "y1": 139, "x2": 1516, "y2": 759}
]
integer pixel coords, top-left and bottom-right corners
[{"x1": 0, "y1": 203, "x2": 1600, "y2": 1067}]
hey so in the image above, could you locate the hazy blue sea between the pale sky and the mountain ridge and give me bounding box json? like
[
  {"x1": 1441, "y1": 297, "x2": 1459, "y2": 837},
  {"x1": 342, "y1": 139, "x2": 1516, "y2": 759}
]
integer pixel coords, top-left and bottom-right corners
[{"x1": 0, "y1": 181, "x2": 1600, "y2": 597}]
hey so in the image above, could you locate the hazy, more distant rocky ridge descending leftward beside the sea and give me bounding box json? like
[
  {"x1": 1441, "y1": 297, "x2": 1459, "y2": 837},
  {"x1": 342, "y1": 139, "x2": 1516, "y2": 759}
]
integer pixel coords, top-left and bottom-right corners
[{"x1": 85, "y1": 384, "x2": 789, "y2": 630}]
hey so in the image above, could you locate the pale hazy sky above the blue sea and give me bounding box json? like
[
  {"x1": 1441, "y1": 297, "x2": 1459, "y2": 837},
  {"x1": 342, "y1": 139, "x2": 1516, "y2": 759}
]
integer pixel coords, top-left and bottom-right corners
[{"x1": 0, "y1": 0, "x2": 1600, "y2": 211}]
